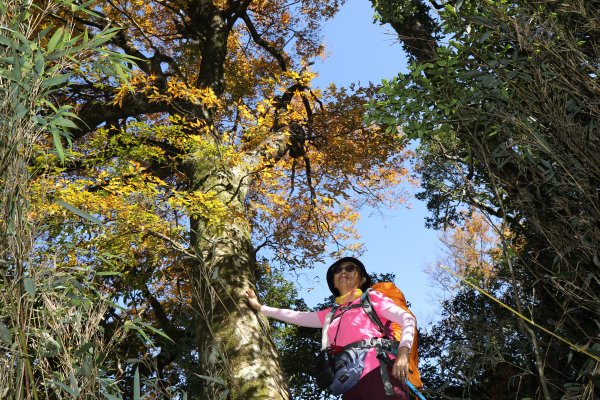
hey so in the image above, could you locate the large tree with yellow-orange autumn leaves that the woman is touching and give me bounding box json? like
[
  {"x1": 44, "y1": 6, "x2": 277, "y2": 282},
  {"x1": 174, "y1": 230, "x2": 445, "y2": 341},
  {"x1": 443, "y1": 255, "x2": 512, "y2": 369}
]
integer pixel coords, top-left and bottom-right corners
[{"x1": 29, "y1": 0, "x2": 407, "y2": 399}]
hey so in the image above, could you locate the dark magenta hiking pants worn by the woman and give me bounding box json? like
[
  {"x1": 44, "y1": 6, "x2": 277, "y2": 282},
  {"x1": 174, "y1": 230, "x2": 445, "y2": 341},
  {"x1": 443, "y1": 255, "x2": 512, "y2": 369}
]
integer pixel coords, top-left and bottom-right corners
[{"x1": 342, "y1": 368, "x2": 409, "y2": 400}]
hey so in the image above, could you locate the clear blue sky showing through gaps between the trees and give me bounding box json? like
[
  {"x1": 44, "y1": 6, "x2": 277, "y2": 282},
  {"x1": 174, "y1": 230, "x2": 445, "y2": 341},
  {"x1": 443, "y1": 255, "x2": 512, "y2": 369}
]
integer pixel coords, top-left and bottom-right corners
[{"x1": 292, "y1": 0, "x2": 441, "y2": 327}]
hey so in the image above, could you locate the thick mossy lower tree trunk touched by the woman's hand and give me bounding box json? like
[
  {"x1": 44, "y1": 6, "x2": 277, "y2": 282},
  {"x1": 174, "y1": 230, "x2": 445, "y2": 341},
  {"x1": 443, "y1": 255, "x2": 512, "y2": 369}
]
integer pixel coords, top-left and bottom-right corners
[{"x1": 187, "y1": 156, "x2": 289, "y2": 399}]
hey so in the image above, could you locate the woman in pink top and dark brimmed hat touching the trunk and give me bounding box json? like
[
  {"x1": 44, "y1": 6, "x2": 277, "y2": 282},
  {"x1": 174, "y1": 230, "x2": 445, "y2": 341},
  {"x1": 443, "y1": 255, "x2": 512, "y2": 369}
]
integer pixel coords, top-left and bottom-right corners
[{"x1": 246, "y1": 257, "x2": 416, "y2": 400}]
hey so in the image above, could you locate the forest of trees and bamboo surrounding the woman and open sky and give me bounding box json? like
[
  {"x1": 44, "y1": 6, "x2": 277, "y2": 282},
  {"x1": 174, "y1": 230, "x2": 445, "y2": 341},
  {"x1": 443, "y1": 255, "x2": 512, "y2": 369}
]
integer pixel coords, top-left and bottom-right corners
[{"x1": 0, "y1": 0, "x2": 600, "y2": 400}]
